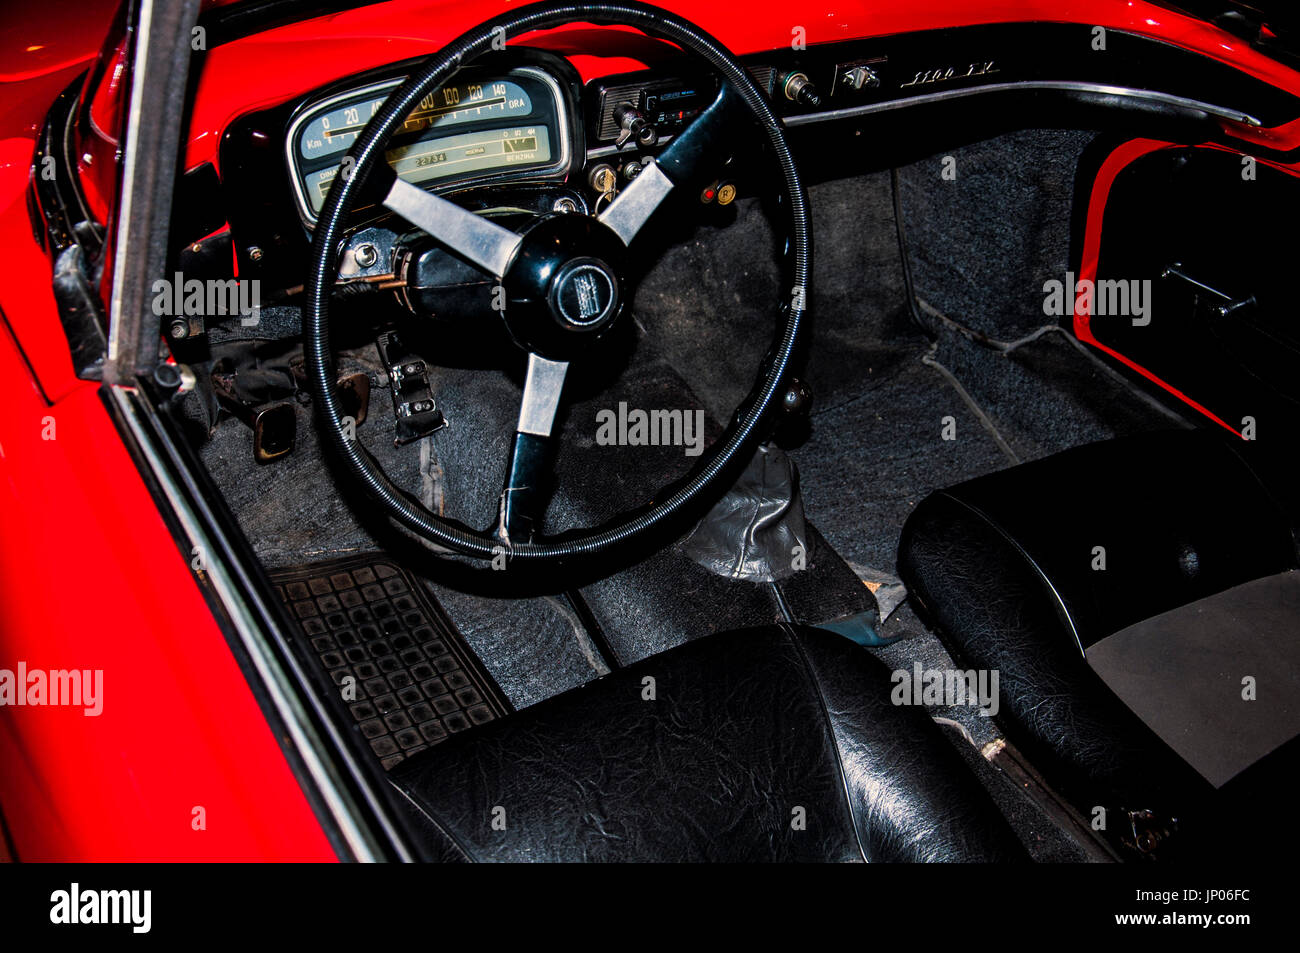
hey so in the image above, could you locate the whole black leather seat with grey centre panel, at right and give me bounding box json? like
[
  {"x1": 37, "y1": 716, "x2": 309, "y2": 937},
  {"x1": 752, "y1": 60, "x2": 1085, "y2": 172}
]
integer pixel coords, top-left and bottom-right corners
[{"x1": 898, "y1": 432, "x2": 1300, "y2": 852}]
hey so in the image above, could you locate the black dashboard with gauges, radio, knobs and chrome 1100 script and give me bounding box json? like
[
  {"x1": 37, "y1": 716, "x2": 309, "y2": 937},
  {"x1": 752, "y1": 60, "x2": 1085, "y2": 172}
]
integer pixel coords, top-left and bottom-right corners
[{"x1": 192, "y1": 22, "x2": 1300, "y2": 297}]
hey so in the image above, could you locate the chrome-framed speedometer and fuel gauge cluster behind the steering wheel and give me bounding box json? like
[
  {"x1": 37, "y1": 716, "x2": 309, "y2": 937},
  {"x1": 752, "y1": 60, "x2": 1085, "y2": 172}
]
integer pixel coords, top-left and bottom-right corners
[{"x1": 285, "y1": 66, "x2": 569, "y2": 225}]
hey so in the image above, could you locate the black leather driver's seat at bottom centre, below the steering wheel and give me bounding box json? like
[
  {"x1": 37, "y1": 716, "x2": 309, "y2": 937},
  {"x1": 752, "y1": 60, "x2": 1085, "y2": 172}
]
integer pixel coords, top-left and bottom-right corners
[{"x1": 391, "y1": 627, "x2": 1023, "y2": 861}]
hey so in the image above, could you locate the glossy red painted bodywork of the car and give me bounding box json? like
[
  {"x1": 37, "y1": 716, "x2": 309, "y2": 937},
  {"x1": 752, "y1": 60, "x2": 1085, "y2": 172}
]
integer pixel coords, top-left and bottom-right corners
[{"x1": 0, "y1": 0, "x2": 1300, "y2": 861}]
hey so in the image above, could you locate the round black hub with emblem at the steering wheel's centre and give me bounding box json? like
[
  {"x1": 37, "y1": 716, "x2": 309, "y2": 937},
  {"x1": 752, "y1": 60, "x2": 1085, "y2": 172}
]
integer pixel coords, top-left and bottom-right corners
[{"x1": 502, "y1": 213, "x2": 625, "y2": 360}]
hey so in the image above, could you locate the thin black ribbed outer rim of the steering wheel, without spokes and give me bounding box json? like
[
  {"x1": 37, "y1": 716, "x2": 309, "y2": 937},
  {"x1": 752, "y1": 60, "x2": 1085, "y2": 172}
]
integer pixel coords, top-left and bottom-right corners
[{"x1": 303, "y1": 1, "x2": 811, "y2": 563}]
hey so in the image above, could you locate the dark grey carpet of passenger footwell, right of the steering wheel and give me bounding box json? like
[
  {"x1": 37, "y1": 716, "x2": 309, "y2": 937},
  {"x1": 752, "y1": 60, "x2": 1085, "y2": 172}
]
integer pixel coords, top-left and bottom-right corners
[{"x1": 793, "y1": 130, "x2": 1183, "y2": 571}]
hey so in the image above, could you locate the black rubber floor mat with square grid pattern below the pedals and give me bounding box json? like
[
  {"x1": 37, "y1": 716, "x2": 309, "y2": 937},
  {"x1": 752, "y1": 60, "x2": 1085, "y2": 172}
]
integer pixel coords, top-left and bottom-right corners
[{"x1": 270, "y1": 553, "x2": 511, "y2": 771}]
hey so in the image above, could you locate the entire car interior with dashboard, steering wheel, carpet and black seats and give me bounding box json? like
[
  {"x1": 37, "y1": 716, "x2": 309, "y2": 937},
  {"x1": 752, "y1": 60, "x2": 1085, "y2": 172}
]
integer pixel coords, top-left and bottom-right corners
[{"x1": 34, "y1": 0, "x2": 1300, "y2": 862}]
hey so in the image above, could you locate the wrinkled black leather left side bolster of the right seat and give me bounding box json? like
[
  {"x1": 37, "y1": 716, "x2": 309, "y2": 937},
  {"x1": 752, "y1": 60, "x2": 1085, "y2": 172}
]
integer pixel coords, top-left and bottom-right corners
[{"x1": 898, "y1": 493, "x2": 1200, "y2": 806}]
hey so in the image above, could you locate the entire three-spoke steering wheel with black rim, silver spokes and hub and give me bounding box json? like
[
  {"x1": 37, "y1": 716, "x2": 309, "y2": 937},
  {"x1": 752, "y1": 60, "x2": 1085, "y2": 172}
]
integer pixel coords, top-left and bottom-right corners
[{"x1": 304, "y1": 3, "x2": 811, "y2": 563}]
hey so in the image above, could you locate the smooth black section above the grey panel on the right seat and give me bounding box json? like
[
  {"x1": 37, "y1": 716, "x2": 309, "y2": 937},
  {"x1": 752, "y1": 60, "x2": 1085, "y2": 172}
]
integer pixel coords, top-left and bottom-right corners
[{"x1": 920, "y1": 430, "x2": 1296, "y2": 651}]
